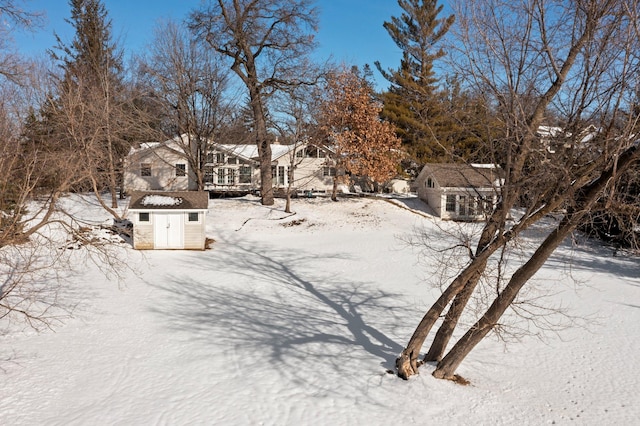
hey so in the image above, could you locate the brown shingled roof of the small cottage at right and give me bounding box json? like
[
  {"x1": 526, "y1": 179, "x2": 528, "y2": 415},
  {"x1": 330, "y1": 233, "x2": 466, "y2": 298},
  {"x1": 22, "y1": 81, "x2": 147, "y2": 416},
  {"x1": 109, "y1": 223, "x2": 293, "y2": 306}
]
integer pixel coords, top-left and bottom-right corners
[{"x1": 423, "y1": 163, "x2": 502, "y2": 188}]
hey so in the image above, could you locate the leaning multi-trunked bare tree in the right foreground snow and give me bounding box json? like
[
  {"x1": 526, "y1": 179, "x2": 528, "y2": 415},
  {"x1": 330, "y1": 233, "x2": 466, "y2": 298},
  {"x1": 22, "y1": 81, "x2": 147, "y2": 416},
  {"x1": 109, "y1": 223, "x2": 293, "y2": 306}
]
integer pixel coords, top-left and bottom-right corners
[{"x1": 396, "y1": 0, "x2": 638, "y2": 379}]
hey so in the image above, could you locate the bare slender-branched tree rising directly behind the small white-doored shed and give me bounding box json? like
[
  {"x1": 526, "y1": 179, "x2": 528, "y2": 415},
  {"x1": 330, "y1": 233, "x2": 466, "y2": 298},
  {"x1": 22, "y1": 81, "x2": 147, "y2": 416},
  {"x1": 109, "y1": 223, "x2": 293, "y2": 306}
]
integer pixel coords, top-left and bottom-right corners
[{"x1": 140, "y1": 22, "x2": 232, "y2": 190}]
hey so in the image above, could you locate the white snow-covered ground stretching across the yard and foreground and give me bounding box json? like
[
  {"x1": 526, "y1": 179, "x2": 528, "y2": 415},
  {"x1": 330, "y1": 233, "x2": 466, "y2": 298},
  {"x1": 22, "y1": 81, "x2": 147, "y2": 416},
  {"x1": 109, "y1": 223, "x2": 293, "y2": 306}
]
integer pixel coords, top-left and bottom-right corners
[{"x1": 0, "y1": 198, "x2": 640, "y2": 425}]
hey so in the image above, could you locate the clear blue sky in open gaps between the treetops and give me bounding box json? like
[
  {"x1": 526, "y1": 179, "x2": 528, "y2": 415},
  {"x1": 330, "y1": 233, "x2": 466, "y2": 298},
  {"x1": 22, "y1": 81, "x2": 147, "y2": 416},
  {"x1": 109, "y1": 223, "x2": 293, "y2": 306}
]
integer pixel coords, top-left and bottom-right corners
[{"x1": 14, "y1": 0, "x2": 401, "y2": 89}]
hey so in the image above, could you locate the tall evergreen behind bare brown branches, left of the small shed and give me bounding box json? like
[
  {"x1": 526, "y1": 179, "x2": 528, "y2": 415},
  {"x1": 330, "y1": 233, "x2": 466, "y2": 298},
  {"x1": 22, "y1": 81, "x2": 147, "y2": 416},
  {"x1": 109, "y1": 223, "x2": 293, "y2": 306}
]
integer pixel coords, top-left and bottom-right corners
[{"x1": 50, "y1": 0, "x2": 130, "y2": 213}]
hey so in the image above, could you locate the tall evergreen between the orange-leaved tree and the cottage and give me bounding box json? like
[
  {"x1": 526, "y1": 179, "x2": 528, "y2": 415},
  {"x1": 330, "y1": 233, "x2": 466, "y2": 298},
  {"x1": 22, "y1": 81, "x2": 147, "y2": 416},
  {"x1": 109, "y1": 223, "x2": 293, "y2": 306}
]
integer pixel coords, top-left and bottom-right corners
[{"x1": 376, "y1": 0, "x2": 455, "y2": 163}]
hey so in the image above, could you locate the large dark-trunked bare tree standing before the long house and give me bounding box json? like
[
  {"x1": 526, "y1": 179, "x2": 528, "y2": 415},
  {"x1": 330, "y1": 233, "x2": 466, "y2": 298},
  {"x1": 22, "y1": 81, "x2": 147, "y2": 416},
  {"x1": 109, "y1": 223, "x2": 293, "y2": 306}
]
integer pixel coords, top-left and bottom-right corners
[{"x1": 190, "y1": 0, "x2": 317, "y2": 205}]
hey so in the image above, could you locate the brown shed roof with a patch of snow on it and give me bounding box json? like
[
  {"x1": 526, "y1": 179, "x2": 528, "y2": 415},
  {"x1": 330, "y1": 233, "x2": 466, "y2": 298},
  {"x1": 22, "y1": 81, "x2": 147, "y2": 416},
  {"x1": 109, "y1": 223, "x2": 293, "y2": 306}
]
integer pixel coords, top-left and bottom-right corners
[{"x1": 129, "y1": 191, "x2": 209, "y2": 210}]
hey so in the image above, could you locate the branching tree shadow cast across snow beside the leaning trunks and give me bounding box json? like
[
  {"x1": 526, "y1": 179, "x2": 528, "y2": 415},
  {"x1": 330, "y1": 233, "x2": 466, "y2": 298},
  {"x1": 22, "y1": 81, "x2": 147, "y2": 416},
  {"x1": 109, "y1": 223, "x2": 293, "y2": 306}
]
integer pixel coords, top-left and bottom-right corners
[{"x1": 146, "y1": 242, "x2": 406, "y2": 386}]
